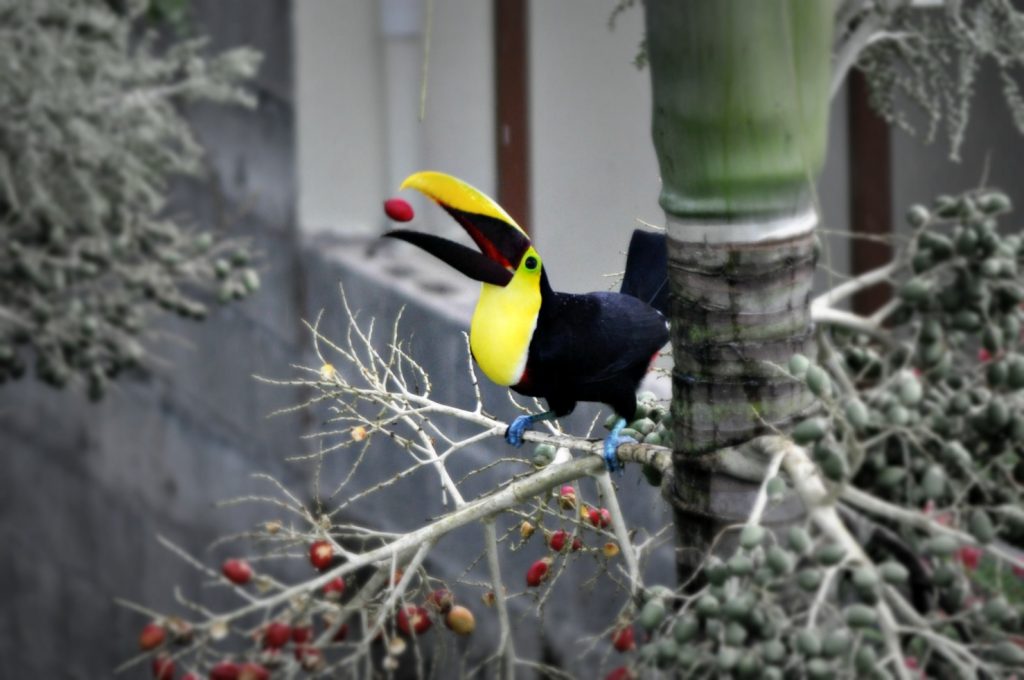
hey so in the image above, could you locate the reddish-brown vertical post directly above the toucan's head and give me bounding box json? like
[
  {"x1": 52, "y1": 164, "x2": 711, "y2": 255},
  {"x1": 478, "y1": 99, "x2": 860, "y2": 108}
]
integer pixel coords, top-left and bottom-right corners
[{"x1": 494, "y1": 0, "x2": 530, "y2": 231}]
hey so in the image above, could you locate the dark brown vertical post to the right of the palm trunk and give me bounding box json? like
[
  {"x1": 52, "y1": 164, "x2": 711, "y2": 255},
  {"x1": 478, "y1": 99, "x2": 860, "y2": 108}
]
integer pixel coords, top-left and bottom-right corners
[{"x1": 848, "y1": 71, "x2": 893, "y2": 314}]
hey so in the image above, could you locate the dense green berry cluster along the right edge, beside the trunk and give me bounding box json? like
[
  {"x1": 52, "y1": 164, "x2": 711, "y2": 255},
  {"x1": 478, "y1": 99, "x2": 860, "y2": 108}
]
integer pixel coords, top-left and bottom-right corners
[{"x1": 843, "y1": 187, "x2": 1024, "y2": 545}]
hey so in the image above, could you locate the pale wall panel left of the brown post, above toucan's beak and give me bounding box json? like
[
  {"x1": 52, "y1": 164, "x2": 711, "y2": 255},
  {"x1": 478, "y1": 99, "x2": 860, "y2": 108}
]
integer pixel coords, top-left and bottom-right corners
[{"x1": 294, "y1": 0, "x2": 496, "y2": 236}]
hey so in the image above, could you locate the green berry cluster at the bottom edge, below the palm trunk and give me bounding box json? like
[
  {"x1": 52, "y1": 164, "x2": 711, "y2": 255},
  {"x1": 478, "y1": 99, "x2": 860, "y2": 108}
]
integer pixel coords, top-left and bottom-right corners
[{"x1": 622, "y1": 525, "x2": 907, "y2": 678}]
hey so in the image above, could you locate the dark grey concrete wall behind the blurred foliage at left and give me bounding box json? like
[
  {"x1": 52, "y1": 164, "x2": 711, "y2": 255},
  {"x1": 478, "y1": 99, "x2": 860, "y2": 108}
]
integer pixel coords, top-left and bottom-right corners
[{"x1": 0, "y1": 0, "x2": 310, "y2": 680}]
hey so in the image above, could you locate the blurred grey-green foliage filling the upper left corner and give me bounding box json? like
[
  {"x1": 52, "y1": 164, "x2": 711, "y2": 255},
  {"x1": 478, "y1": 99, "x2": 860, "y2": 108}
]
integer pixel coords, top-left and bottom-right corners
[{"x1": 0, "y1": 0, "x2": 259, "y2": 398}]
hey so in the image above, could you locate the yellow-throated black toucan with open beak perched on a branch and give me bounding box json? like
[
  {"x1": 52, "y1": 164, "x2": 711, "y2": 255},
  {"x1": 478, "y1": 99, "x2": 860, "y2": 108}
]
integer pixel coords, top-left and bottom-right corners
[{"x1": 384, "y1": 171, "x2": 669, "y2": 470}]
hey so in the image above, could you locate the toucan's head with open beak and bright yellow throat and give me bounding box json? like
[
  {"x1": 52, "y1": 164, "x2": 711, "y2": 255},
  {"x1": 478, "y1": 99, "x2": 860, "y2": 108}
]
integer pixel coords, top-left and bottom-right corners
[{"x1": 386, "y1": 172, "x2": 543, "y2": 385}]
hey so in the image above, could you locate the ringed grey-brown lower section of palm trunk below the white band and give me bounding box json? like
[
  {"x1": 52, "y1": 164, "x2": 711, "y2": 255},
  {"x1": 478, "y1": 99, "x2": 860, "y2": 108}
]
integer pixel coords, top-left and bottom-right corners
[{"x1": 667, "y1": 229, "x2": 815, "y2": 579}]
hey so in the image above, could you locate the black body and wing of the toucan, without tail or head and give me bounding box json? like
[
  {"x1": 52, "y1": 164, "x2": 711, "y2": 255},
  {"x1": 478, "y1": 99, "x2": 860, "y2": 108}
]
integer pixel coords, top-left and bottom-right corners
[{"x1": 517, "y1": 293, "x2": 669, "y2": 417}]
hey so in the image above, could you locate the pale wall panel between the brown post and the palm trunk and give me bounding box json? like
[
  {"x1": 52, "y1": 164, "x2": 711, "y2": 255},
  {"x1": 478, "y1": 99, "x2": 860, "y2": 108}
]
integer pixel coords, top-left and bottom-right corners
[{"x1": 529, "y1": 0, "x2": 664, "y2": 292}]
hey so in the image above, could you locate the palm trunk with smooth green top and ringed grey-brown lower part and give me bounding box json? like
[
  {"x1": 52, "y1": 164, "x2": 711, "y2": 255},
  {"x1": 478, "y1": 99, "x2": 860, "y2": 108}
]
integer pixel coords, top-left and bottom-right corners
[{"x1": 646, "y1": 0, "x2": 835, "y2": 582}]
